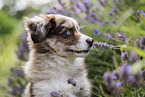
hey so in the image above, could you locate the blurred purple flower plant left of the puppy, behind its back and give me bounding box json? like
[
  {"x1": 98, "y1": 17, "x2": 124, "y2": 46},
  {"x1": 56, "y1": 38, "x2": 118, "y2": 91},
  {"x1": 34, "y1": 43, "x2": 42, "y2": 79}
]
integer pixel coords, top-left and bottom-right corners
[{"x1": 8, "y1": 34, "x2": 29, "y2": 97}]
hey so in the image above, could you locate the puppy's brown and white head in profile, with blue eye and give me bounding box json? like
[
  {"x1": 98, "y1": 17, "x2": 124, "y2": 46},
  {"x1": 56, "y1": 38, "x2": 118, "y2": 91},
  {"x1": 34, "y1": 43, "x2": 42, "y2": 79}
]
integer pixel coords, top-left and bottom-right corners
[{"x1": 24, "y1": 14, "x2": 93, "y2": 57}]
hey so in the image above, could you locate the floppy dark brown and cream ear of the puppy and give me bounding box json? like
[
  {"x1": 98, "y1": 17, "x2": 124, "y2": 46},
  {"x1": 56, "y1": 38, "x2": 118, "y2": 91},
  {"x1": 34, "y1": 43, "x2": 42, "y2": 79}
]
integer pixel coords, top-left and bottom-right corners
[{"x1": 24, "y1": 15, "x2": 56, "y2": 43}]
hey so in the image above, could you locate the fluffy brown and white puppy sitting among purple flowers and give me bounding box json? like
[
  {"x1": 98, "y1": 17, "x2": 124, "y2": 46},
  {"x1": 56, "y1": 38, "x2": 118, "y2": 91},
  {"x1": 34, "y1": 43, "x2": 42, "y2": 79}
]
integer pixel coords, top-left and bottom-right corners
[{"x1": 23, "y1": 14, "x2": 93, "y2": 97}]
